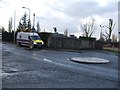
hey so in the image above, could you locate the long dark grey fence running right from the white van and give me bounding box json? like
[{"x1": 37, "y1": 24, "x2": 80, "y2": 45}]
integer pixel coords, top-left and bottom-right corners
[{"x1": 48, "y1": 37, "x2": 95, "y2": 49}]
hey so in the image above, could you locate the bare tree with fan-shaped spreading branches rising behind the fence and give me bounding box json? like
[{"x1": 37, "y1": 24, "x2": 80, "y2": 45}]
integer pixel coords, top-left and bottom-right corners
[{"x1": 81, "y1": 18, "x2": 95, "y2": 37}]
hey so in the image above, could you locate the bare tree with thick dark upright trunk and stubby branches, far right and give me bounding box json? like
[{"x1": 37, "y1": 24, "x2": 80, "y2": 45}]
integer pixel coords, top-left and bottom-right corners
[{"x1": 103, "y1": 19, "x2": 116, "y2": 41}]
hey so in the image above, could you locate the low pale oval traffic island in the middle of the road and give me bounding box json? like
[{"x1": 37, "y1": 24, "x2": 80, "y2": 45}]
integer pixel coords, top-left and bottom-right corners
[{"x1": 69, "y1": 57, "x2": 109, "y2": 64}]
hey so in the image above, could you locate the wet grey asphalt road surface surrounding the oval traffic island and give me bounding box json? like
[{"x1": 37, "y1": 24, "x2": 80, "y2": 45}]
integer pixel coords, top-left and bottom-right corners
[{"x1": 1, "y1": 43, "x2": 118, "y2": 88}]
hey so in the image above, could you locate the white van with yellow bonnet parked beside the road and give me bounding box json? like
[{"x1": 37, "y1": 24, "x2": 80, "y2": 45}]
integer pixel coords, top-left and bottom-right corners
[{"x1": 16, "y1": 32, "x2": 44, "y2": 48}]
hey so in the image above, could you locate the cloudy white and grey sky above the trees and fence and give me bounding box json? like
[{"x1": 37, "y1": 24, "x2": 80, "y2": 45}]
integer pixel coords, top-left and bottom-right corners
[{"x1": 0, "y1": 0, "x2": 119, "y2": 38}]
